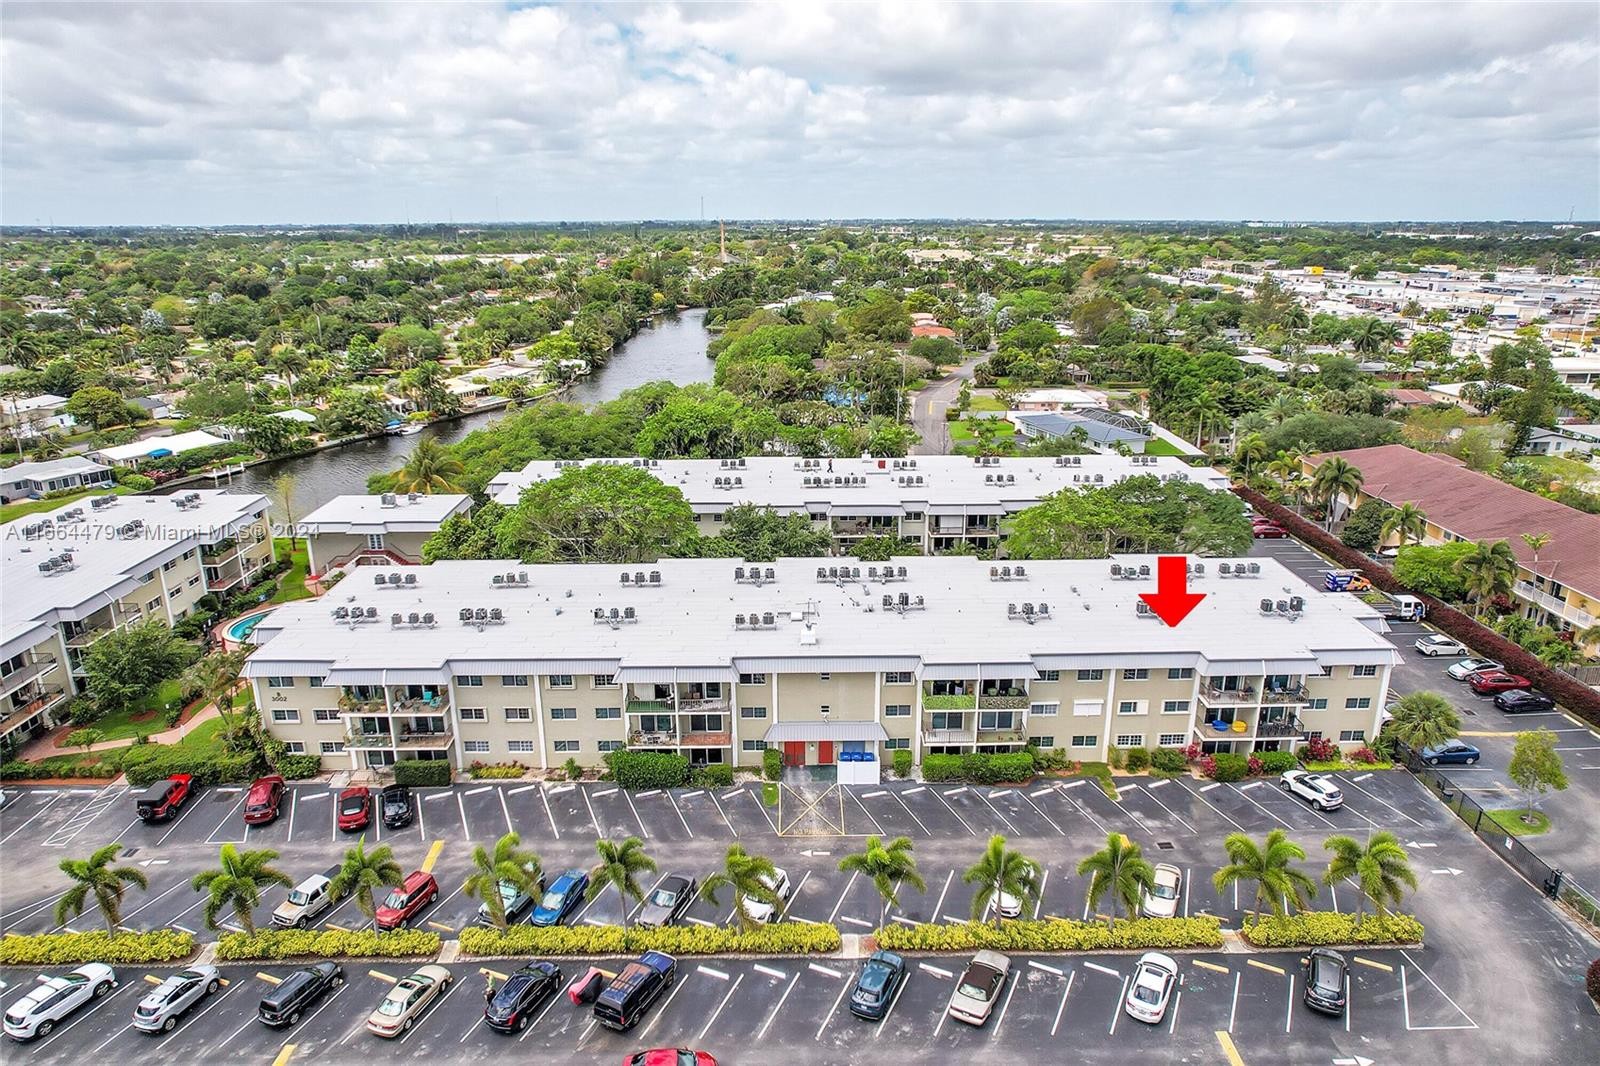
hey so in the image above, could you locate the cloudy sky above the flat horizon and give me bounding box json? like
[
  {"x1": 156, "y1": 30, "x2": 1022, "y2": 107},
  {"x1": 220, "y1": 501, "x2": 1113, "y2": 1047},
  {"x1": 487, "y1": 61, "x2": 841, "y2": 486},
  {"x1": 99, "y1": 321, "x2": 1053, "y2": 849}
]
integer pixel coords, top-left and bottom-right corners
[{"x1": 0, "y1": 0, "x2": 1600, "y2": 224}]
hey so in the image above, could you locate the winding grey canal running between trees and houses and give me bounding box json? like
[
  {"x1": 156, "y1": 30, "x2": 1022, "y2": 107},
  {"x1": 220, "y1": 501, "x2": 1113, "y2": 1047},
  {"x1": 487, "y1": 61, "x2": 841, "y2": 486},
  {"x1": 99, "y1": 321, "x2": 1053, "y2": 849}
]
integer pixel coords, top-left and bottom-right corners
[{"x1": 221, "y1": 307, "x2": 715, "y2": 515}]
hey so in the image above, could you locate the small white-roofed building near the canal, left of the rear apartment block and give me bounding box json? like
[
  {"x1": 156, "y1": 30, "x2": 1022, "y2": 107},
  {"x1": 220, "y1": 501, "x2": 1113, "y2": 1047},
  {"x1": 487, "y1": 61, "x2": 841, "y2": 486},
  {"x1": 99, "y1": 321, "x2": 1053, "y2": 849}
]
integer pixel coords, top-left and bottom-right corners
[{"x1": 296, "y1": 493, "x2": 472, "y2": 578}]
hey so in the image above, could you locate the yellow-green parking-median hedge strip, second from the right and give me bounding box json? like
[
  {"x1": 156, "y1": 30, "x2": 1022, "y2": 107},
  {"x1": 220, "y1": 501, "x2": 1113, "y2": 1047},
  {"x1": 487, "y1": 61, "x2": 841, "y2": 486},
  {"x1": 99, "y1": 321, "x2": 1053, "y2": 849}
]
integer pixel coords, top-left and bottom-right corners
[{"x1": 877, "y1": 917, "x2": 1222, "y2": 952}]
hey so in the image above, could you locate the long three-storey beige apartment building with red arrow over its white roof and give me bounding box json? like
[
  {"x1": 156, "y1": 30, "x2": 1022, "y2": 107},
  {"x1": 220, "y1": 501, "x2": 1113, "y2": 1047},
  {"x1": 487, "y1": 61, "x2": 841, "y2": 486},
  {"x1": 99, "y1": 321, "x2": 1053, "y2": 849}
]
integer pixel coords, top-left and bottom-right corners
[{"x1": 245, "y1": 555, "x2": 1398, "y2": 768}]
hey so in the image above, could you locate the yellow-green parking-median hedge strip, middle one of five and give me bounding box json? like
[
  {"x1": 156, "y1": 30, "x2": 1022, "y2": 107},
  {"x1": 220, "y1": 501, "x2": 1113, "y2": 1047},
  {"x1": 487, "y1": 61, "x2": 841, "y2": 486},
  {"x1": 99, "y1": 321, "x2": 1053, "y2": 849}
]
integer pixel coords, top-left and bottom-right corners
[{"x1": 461, "y1": 922, "x2": 840, "y2": 956}]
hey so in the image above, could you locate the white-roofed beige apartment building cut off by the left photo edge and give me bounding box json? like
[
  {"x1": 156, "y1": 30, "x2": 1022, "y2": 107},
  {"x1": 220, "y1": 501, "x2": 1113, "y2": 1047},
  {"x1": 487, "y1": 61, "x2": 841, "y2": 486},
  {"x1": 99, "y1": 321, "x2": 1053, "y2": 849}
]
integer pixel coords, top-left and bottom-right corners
[{"x1": 0, "y1": 490, "x2": 274, "y2": 751}]
